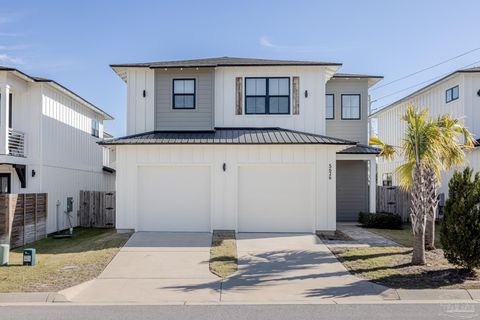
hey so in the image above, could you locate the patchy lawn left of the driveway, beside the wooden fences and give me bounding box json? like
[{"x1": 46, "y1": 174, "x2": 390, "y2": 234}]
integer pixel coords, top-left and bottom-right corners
[{"x1": 0, "y1": 228, "x2": 130, "y2": 292}]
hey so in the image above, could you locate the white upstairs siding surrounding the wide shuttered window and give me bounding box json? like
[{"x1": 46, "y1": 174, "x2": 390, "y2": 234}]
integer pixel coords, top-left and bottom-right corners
[{"x1": 215, "y1": 66, "x2": 328, "y2": 134}]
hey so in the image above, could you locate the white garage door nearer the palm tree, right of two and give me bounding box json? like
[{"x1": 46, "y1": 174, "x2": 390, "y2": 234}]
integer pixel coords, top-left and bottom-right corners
[{"x1": 238, "y1": 165, "x2": 315, "y2": 232}]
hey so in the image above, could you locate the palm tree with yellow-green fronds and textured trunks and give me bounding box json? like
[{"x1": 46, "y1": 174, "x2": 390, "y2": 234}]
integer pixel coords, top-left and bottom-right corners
[{"x1": 370, "y1": 105, "x2": 474, "y2": 265}]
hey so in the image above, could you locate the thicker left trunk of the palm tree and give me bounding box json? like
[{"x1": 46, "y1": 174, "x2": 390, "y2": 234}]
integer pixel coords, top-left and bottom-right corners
[{"x1": 410, "y1": 164, "x2": 428, "y2": 265}]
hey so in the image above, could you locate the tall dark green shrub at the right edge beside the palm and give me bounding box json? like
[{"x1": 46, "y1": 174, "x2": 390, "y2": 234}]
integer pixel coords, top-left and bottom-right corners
[{"x1": 440, "y1": 168, "x2": 480, "y2": 270}]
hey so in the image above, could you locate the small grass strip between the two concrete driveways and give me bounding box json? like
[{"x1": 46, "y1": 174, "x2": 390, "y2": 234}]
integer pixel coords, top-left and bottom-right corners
[{"x1": 210, "y1": 231, "x2": 237, "y2": 278}]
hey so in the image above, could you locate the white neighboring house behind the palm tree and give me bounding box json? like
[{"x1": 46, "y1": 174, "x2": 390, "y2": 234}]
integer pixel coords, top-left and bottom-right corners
[{"x1": 370, "y1": 67, "x2": 480, "y2": 195}]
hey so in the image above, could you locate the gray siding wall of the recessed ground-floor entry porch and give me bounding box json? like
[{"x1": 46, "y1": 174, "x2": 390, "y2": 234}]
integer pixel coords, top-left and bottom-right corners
[{"x1": 337, "y1": 160, "x2": 368, "y2": 221}]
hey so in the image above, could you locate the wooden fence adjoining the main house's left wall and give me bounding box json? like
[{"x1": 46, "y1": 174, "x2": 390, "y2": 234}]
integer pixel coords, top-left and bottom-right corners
[{"x1": 78, "y1": 191, "x2": 115, "y2": 228}]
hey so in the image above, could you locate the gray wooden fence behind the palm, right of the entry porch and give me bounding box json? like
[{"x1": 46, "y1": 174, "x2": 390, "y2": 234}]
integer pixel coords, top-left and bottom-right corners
[{"x1": 376, "y1": 186, "x2": 411, "y2": 221}]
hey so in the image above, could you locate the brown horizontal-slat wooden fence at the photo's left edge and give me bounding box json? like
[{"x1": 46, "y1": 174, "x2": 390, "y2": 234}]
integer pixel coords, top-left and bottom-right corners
[{"x1": 0, "y1": 193, "x2": 48, "y2": 248}]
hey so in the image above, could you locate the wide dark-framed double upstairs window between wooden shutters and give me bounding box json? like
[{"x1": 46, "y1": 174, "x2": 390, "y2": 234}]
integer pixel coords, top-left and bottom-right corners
[{"x1": 245, "y1": 78, "x2": 290, "y2": 114}]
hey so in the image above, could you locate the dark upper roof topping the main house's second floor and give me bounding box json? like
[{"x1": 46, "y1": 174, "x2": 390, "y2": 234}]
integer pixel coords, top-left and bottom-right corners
[{"x1": 110, "y1": 57, "x2": 342, "y2": 68}]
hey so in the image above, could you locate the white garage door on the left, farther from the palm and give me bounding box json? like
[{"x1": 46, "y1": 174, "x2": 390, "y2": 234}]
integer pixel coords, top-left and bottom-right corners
[{"x1": 137, "y1": 166, "x2": 210, "y2": 232}]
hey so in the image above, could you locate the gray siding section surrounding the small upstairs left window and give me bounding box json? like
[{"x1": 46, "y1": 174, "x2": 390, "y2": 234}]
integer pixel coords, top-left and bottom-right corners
[{"x1": 155, "y1": 69, "x2": 215, "y2": 130}]
